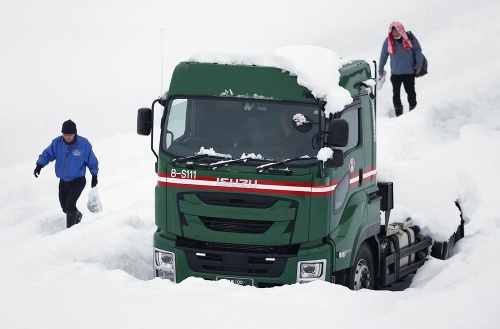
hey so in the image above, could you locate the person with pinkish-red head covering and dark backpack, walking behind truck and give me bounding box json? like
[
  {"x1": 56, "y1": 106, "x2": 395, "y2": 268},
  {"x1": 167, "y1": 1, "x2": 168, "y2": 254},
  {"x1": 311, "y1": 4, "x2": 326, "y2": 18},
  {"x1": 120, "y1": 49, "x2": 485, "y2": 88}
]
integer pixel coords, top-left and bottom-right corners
[{"x1": 379, "y1": 21, "x2": 424, "y2": 116}]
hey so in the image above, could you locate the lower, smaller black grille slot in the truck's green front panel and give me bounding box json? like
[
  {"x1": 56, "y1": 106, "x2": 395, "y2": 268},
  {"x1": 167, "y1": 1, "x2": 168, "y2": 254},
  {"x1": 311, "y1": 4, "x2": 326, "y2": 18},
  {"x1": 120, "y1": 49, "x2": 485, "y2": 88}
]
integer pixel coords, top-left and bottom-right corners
[{"x1": 200, "y1": 217, "x2": 273, "y2": 234}]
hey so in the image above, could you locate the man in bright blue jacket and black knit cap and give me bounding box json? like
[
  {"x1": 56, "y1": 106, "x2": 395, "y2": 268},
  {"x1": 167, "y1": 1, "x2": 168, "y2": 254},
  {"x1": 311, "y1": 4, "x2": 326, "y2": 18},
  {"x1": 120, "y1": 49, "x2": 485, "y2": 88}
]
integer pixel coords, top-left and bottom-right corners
[{"x1": 33, "y1": 120, "x2": 99, "y2": 228}]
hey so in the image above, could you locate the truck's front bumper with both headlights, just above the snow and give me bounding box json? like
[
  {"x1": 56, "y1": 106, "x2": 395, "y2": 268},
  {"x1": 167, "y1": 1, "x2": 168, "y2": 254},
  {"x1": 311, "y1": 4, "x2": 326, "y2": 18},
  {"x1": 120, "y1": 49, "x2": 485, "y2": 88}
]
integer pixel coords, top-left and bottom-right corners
[{"x1": 154, "y1": 232, "x2": 332, "y2": 287}]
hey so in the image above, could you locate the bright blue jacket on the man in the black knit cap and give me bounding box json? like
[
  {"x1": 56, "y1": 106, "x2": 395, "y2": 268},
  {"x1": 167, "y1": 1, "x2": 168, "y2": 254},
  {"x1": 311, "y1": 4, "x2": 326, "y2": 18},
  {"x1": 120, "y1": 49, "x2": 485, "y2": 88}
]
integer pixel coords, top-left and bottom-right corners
[{"x1": 36, "y1": 135, "x2": 99, "y2": 181}]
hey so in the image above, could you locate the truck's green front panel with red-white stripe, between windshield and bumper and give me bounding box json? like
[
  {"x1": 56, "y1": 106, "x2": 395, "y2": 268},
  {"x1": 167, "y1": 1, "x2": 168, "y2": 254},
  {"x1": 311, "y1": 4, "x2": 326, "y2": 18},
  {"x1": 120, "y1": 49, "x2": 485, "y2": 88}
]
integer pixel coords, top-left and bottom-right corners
[{"x1": 156, "y1": 166, "x2": 333, "y2": 246}]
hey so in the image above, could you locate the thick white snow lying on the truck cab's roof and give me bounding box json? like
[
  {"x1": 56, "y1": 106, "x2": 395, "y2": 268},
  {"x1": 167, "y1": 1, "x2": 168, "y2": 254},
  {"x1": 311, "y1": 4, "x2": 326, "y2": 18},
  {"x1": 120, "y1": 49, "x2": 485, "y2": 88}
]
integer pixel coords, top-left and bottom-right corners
[{"x1": 189, "y1": 46, "x2": 352, "y2": 115}]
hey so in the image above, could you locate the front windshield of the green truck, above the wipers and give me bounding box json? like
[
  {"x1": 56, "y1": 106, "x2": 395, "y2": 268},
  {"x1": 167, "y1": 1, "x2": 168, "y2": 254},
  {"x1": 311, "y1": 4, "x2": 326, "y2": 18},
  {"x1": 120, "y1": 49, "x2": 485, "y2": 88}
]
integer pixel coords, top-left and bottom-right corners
[{"x1": 161, "y1": 98, "x2": 319, "y2": 163}]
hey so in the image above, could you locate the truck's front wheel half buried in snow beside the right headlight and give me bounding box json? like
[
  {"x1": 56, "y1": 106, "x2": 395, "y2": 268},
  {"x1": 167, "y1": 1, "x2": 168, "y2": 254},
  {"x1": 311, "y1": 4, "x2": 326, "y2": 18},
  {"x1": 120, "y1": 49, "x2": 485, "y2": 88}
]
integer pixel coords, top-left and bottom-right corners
[{"x1": 347, "y1": 242, "x2": 375, "y2": 290}]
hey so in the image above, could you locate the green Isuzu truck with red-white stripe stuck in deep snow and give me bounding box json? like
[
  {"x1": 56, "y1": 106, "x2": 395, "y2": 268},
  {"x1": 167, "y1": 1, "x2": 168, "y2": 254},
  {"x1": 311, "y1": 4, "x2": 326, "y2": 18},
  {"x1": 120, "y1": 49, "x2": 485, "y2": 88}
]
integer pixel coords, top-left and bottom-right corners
[{"x1": 137, "y1": 50, "x2": 464, "y2": 290}]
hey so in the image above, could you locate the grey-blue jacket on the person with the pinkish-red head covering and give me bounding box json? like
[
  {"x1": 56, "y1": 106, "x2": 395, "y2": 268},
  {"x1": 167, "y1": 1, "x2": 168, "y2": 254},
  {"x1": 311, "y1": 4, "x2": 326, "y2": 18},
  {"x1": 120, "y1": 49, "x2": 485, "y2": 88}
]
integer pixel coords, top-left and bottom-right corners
[{"x1": 378, "y1": 36, "x2": 424, "y2": 75}]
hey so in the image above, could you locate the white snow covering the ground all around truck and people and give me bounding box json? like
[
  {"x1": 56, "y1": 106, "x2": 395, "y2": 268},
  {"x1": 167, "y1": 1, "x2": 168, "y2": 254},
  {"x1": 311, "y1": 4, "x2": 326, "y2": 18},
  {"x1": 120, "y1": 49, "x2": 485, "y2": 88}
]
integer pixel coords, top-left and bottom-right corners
[{"x1": 0, "y1": 0, "x2": 500, "y2": 329}]
